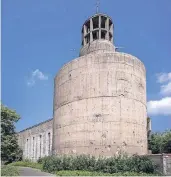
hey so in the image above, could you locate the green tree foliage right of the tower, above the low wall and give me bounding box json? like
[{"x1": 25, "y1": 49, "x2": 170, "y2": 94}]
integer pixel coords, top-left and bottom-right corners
[{"x1": 149, "y1": 129, "x2": 171, "y2": 154}]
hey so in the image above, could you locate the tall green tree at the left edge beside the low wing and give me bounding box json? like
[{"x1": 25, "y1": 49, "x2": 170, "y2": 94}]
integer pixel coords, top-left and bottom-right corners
[{"x1": 1, "y1": 104, "x2": 22, "y2": 163}]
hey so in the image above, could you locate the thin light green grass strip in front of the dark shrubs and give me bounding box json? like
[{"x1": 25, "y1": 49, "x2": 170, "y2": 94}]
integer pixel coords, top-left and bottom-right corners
[{"x1": 56, "y1": 170, "x2": 156, "y2": 176}]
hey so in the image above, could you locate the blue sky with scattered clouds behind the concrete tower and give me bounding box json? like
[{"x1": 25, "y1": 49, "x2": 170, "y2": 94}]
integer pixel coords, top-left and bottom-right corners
[{"x1": 2, "y1": 0, "x2": 171, "y2": 131}]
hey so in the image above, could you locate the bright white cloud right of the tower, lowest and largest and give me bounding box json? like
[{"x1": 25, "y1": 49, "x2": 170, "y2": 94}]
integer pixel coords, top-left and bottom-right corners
[{"x1": 147, "y1": 97, "x2": 171, "y2": 115}]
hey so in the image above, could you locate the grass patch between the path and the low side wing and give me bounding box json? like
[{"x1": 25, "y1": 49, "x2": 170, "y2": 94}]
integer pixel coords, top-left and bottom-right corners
[{"x1": 8, "y1": 161, "x2": 42, "y2": 170}]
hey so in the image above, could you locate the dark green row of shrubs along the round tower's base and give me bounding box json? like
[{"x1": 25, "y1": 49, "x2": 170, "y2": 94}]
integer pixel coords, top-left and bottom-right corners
[{"x1": 39, "y1": 155, "x2": 158, "y2": 174}]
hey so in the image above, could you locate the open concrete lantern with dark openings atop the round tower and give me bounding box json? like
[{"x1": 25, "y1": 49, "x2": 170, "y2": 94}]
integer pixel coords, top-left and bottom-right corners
[{"x1": 80, "y1": 14, "x2": 115, "y2": 56}]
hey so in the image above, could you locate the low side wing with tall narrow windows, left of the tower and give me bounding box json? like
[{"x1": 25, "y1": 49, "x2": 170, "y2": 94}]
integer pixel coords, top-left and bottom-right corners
[{"x1": 18, "y1": 119, "x2": 53, "y2": 161}]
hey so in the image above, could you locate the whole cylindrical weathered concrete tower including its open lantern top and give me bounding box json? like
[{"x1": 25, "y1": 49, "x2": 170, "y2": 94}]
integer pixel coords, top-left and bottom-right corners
[{"x1": 53, "y1": 14, "x2": 147, "y2": 156}]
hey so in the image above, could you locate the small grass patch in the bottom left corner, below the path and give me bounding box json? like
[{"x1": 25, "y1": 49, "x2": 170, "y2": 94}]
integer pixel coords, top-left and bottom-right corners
[{"x1": 1, "y1": 165, "x2": 20, "y2": 176}]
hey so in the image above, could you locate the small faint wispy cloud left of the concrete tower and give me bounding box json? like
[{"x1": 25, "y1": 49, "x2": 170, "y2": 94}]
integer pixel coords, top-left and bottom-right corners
[{"x1": 27, "y1": 69, "x2": 48, "y2": 86}]
